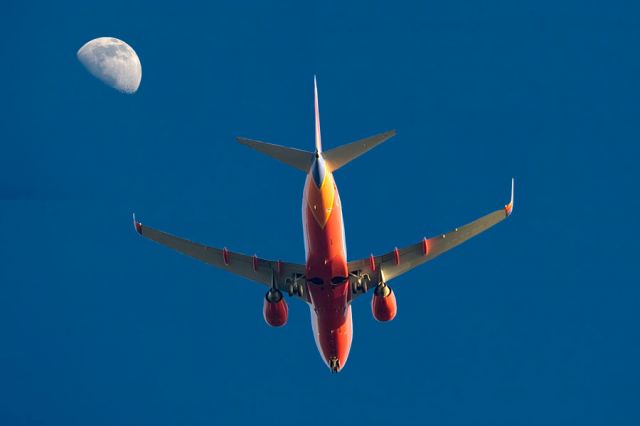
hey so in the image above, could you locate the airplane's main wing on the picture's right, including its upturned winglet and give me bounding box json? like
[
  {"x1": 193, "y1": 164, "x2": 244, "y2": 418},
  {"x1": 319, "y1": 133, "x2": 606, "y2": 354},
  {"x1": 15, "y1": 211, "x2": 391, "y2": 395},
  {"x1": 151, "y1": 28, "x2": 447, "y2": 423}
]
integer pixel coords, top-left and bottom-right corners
[{"x1": 348, "y1": 179, "x2": 514, "y2": 298}]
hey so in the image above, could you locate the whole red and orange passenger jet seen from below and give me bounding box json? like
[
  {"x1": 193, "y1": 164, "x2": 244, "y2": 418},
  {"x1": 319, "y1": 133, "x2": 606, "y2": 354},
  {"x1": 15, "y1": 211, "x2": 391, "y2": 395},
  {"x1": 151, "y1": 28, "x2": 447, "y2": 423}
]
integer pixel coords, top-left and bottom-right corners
[{"x1": 133, "y1": 76, "x2": 514, "y2": 373}]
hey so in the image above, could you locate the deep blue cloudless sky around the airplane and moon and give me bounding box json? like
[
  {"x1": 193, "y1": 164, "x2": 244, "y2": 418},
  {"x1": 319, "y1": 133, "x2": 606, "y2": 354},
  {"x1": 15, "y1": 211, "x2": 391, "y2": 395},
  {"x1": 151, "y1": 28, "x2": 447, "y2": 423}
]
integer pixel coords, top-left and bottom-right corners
[{"x1": 0, "y1": 0, "x2": 640, "y2": 426}]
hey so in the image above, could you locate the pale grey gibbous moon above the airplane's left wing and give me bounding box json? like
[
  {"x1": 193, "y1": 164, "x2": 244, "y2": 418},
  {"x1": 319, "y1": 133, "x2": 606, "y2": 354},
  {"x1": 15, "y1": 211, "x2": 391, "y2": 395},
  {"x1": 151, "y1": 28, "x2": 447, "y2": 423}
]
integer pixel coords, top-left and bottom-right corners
[{"x1": 77, "y1": 37, "x2": 142, "y2": 94}]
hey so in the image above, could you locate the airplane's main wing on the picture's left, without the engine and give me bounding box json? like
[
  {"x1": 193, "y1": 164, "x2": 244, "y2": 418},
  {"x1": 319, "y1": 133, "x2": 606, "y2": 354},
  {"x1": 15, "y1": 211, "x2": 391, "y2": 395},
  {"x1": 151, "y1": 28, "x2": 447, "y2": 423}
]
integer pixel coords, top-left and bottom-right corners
[{"x1": 133, "y1": 214, "x2": 308, "y2": 302}]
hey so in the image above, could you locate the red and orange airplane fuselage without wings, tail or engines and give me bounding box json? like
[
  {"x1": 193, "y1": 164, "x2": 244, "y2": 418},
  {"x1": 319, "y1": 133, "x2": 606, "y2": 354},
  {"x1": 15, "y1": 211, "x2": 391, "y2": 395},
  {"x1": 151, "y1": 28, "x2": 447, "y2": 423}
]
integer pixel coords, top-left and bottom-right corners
[{"x1": 302, "y1": 154, "x2": 353, "y2": 372}]
